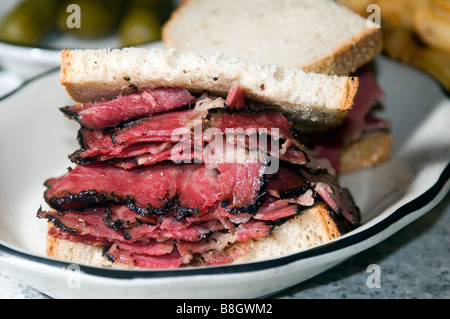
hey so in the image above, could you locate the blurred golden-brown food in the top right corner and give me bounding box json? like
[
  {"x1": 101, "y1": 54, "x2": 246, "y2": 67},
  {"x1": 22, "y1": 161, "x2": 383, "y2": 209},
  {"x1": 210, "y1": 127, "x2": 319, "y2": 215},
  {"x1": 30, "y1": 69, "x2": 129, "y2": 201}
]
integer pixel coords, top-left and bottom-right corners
[{"x1": 337, "y1": 0, "x2": 450, "y2": 91}]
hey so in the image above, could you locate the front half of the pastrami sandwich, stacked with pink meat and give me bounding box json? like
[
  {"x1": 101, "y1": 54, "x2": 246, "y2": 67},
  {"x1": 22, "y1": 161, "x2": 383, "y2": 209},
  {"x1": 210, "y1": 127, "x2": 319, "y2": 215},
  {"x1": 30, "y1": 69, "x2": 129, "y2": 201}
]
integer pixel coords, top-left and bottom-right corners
[{"x1": 38, "y1": 48, "x2": 360, "y2": 269}]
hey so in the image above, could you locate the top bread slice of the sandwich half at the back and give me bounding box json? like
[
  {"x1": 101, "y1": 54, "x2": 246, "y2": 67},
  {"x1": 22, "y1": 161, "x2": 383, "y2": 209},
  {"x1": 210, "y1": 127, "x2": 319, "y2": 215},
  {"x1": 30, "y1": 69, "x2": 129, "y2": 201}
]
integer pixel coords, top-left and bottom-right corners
[{"x1": 163, "y1": 0, "x2": 382, "y2": 75}]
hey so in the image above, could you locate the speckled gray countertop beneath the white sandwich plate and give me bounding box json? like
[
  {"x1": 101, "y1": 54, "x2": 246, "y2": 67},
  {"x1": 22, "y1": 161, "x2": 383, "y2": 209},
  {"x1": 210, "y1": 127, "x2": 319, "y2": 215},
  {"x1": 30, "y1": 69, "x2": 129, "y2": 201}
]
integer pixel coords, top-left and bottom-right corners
[{"x1": 0, "y1": 194, "x2": 450, "y2": 299}]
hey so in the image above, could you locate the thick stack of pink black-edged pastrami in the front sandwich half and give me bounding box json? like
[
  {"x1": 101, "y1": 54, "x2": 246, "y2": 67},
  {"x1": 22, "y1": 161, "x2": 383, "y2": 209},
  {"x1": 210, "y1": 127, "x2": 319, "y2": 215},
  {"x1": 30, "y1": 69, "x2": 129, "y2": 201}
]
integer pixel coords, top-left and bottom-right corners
[{"x1": 38, "y1": 86, "x2": 359, "y2": 268}]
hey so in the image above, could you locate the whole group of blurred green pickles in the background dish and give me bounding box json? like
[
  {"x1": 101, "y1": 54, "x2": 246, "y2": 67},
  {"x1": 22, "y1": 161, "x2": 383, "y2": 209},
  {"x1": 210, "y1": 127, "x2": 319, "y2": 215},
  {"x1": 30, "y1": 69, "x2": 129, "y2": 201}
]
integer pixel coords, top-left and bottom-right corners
[{"x1": 0, "y1": 0, "x2": 173, "y2": 46}]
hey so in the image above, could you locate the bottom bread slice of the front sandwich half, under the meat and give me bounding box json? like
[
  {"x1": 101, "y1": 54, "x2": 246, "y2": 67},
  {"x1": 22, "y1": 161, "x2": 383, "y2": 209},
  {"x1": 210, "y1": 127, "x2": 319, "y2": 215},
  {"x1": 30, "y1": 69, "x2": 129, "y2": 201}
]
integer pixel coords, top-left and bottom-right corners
[{"x1": 46, "y1": 203, "x2": 341, "y2": 269}]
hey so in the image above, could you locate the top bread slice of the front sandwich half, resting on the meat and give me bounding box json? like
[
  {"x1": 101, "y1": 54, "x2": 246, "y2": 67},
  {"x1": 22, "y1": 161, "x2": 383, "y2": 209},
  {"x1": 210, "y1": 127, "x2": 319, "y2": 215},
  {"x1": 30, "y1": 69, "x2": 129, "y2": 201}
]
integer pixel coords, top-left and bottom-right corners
[{"x1": 61, "y1": 48, "x2": 358, "y2": 132}]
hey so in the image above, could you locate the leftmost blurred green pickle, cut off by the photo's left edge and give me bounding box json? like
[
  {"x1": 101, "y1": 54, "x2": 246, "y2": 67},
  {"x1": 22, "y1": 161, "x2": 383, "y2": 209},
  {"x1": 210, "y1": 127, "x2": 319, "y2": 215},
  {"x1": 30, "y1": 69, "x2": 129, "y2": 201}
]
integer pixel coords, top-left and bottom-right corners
[{"x1": 0, "y1": 0, "x2": 61, "y2": 45}]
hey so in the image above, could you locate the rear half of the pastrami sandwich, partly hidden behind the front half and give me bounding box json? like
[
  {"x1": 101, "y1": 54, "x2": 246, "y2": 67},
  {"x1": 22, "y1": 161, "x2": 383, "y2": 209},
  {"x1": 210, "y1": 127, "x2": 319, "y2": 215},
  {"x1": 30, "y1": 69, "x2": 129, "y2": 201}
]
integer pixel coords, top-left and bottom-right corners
[{"x1": 163, "y1": 0, "x2": 392, "y2": 173}]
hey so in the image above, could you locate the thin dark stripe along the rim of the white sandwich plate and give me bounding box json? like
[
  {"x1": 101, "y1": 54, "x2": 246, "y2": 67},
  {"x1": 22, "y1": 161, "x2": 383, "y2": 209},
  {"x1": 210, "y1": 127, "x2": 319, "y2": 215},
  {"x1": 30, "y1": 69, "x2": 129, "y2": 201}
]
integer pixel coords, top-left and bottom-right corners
[{"x1": 0, "y1": 67, "x2": 450, "y2": 280}]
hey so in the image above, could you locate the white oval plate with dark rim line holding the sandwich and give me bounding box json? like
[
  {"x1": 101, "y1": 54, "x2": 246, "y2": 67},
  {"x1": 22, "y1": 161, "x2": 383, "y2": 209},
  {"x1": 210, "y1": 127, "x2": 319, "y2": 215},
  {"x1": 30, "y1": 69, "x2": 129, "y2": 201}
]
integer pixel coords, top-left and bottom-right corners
[{"x1": 0, "y1": 57, "x2": 450, "y2": 298}]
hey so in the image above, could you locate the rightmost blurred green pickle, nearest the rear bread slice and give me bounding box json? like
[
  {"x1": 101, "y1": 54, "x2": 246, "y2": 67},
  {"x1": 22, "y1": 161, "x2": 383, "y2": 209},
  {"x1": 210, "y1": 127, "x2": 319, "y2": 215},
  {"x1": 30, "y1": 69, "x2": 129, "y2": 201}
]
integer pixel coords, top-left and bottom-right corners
[{"x1": 119, "y1": 7, "x2": 161, "y2": 46}]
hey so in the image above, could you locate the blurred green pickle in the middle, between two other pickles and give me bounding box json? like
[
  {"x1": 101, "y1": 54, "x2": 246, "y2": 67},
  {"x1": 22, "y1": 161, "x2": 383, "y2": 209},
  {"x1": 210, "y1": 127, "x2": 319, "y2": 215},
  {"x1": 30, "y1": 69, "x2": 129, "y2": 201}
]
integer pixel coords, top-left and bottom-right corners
[{"x1": 57, "y1": 0, "x2": 123, "y2": 37}]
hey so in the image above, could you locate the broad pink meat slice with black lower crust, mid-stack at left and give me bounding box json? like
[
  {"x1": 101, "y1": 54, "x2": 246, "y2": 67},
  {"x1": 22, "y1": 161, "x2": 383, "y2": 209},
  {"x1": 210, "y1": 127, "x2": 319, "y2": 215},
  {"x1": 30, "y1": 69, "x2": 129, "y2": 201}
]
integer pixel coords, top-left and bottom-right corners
[{"x1": 44, "y1": 163, "x2": 219, "y2": 215}]
